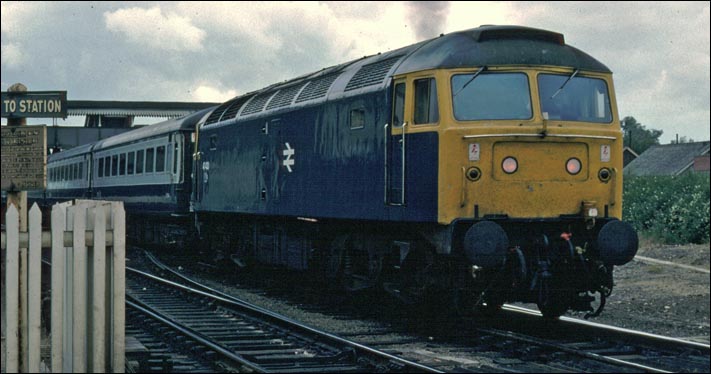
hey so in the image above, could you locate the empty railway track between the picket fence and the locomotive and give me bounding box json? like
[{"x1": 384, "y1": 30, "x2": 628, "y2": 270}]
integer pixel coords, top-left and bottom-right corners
[{"x1": 127, "y1": 258, "x2": 439, "y2": 373}]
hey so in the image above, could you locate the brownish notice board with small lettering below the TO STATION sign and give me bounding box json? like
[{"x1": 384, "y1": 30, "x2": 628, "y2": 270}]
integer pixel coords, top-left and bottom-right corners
[{"x1": 0, "y1": 126, "x2": 47, "y2": 191}]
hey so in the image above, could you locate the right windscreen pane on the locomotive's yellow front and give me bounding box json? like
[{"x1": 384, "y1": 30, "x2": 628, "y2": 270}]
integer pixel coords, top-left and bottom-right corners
[{"x1": 538, "y1": 74, "x2": 612, "y2": 123}]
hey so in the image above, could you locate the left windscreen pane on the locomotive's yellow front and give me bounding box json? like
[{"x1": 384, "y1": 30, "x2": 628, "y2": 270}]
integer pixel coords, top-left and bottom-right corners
[{"x1": 452, "y1": 73, "x2": 533, "y2": 121}]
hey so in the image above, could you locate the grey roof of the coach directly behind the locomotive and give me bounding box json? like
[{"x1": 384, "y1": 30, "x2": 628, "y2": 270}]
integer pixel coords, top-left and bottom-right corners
[{"x1": 94, "y1": 107, "x2": 215, "y2": 151}]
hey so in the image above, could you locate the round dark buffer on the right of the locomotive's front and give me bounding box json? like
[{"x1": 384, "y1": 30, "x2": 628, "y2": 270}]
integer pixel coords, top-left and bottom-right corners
[{"x1": 597, "y1": 221, "x2": 639, "y2": 265}]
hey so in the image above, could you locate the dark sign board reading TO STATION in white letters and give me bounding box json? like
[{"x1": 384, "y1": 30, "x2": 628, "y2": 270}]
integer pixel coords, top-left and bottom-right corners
[{"x1": 0, "y1": 91, "x2": 67, "y2": 118}]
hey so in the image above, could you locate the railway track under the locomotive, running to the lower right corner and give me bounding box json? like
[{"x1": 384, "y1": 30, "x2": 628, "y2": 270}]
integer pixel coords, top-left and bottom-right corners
[{"x1": 142, "y1": 250, "x2": 709, "y2": 373}]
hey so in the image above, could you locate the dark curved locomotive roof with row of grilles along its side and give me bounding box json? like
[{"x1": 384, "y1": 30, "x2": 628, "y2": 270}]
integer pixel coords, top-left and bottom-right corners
[{"x1": 205, "y1": 26, "x2": 610, "y2": 126}]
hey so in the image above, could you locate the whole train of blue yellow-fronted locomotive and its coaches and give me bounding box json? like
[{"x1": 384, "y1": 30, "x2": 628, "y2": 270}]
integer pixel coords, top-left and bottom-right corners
[{"x1": 49, "y1": 26, "x2": 637, "y2": 317}]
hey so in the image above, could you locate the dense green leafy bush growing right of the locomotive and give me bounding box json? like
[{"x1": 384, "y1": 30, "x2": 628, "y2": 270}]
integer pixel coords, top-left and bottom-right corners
[{"x1": 623, "y1": 174, "x2": 711, "y2": 244}]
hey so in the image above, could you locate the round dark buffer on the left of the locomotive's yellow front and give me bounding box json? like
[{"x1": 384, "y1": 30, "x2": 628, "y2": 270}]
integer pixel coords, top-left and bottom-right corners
[{"x1": 464, "y1": 221, "x2": 509, "y2": 268}]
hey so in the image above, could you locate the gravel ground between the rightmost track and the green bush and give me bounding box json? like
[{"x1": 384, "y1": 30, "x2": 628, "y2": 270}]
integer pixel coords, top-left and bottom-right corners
[{"x1": 572, "y1": 242, "x2": 710, "y2": 344}]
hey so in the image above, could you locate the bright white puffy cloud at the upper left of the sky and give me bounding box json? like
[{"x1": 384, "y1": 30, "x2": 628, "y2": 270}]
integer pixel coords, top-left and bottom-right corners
[{"x1": 104, "y1": 6, "x2": 206, "y2": 51}]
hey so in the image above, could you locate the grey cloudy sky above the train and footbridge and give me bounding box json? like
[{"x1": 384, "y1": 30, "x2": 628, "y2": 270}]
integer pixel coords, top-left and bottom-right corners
[{"x1": 0, "y1": 1, "x2": 711, "y2": 144}]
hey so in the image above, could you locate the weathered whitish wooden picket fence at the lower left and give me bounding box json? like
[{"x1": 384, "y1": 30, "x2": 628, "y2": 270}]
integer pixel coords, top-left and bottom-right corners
[{"x1": 2, "y1": 200, "x2": 125, "y2": 373}]
